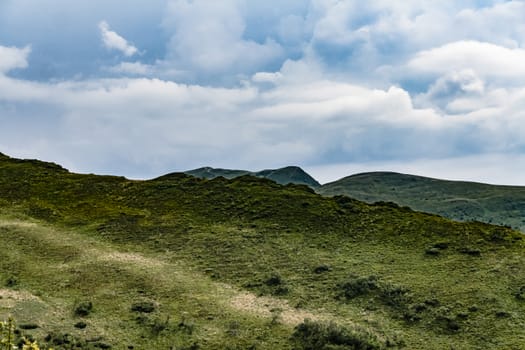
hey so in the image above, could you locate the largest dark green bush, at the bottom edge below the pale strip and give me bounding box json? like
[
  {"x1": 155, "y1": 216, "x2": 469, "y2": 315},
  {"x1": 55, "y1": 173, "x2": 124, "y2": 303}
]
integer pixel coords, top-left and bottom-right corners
[{"x1": 292, "y1": 319, "x2": 384, "y2": 350}]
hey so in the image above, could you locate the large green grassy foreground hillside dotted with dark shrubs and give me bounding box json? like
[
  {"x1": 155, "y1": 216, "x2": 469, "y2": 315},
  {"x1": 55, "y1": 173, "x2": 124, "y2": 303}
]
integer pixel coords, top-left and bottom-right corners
[{"x1": 0, "y1": 156, "x2": 525, "y2": 349}]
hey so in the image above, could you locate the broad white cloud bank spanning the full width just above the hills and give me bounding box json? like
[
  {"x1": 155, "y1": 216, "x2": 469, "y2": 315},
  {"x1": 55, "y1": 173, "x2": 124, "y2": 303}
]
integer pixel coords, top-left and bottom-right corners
[{"x1": 0, "y1": 59, "x2": 525, "y2": 182}]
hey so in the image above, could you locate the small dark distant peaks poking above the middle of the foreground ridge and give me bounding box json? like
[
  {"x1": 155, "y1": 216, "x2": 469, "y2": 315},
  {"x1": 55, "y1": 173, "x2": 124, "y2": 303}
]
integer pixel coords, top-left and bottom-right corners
[{"x1": 185, "y1": 166, "x2": 321, "y2": 188}]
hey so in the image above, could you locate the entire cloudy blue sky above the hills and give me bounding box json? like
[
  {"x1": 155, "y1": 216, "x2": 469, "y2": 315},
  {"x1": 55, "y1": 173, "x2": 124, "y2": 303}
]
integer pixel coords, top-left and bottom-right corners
[{"x1": 0, "y1": 0, "x2": 525, "y2": 185}]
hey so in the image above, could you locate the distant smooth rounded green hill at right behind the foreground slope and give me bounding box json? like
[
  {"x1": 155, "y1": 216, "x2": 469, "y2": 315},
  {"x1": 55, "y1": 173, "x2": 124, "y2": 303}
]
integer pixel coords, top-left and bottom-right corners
[{"x1": 318, "y1": 172, "x2": 525, "y2": 232}]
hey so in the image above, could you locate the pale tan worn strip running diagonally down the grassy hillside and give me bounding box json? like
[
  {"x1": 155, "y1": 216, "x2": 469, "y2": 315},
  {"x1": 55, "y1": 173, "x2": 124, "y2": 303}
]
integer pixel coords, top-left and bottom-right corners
[{"x1": 0, "y1": 220, "x2": 334, "y2": 326}]
